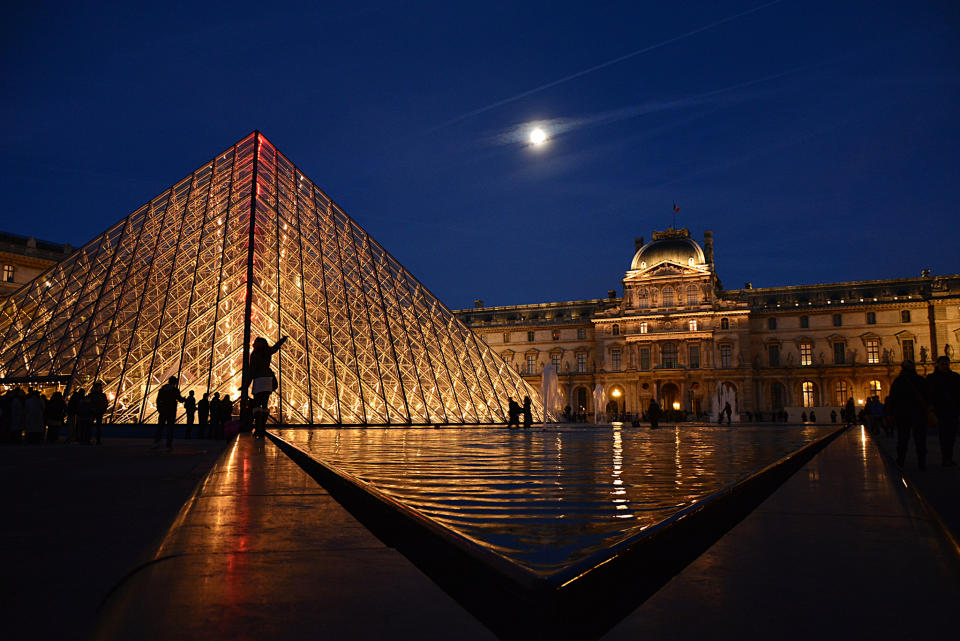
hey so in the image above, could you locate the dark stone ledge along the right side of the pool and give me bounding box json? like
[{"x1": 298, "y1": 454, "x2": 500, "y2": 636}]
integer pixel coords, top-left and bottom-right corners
[{"x1": 603, "y1": 428, "x2": 960, "y2": 641}]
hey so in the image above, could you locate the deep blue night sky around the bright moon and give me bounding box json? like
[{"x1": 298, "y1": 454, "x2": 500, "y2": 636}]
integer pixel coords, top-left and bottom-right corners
[{"x1": 0, "y1": 0, "x2": 960, "y2": 308}]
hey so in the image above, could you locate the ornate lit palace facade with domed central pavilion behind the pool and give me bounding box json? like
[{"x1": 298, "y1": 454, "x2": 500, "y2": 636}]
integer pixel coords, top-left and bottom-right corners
[{"x1": 455, "y1": 229, "x2": 960, "y2": 423}]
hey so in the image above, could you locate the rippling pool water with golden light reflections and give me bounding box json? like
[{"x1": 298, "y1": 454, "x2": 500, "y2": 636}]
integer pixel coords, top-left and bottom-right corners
[{"x1": 279, "y1": 426, "x2": 832, "y2": 574}]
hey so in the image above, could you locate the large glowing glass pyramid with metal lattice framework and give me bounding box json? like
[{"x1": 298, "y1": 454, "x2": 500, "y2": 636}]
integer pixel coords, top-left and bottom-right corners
[{"x1": 0, "y1": 132, "x2": 541, "y2": 425}]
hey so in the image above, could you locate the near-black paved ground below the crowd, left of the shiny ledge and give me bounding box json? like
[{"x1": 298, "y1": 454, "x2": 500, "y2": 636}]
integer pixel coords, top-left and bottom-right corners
[{"x1": 0, "y1": 438, "x2": 225, "y2": 641}]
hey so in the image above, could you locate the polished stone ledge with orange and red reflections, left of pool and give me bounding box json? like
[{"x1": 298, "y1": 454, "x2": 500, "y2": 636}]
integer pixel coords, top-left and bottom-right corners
[{"x1": 94, "y1": 435, "x2": 495, "y2": 640}]
